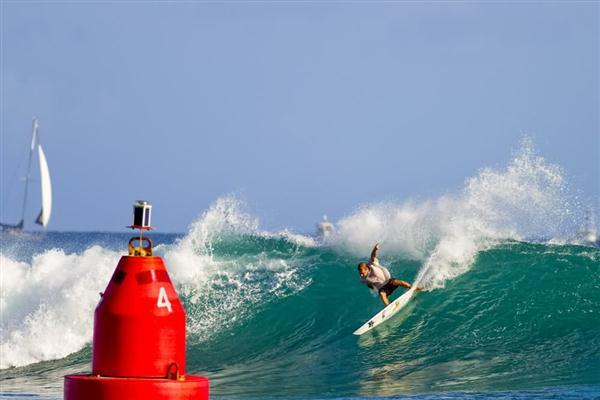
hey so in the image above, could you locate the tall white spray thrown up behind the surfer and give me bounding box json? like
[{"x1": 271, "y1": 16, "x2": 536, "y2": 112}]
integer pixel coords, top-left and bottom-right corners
[{"x1": 335, "y1": 140, "x2": 581, "y2": 289}]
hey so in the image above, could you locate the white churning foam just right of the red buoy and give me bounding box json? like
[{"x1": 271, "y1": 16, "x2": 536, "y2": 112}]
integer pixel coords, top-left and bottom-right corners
[{"x1": 164, "y1": 197, "x2": 314, "y2": 340}]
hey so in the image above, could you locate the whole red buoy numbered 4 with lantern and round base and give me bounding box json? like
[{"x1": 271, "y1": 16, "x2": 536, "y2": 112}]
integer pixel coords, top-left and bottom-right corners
[{"x1": 64, "y1": 202, "x2": 209, "y2": 400}]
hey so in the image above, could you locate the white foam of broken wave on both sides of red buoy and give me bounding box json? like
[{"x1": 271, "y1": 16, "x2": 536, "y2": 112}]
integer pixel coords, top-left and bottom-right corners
[{"x1": 0, "y1": 197, "x2": 308, "y2": 368}]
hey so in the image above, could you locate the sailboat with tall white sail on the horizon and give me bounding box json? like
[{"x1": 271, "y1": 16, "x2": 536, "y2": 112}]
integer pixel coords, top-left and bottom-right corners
[{"x1": 0, "y1": 118, "x2": 52, "y2": 232}]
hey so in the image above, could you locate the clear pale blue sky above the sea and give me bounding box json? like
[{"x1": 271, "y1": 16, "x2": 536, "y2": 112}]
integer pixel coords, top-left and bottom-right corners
[{"x1": 0, "y1": 0, "x2": 600, "y2": 231}]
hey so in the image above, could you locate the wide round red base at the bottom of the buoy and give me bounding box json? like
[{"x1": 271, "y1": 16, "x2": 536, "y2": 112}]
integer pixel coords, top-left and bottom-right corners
[{"x1": 64, "y1": 375, "x2": 209, "y2": 400}]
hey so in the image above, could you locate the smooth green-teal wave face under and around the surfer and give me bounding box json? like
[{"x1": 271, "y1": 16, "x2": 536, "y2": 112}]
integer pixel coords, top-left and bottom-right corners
[{"x1": 180, "y1": 236, "x2": 600, "y2": 397}]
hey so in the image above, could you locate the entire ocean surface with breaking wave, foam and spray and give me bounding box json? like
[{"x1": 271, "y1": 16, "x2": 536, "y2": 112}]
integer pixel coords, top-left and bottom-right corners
[{"x1": 0, "y1": 143, "x2": 600, "y2": 399}]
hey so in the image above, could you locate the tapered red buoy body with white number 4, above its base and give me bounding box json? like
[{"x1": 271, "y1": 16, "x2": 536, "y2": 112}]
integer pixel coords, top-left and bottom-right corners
[{"x1": 92, "y1": 256, "x2": 185, "y2": 378}]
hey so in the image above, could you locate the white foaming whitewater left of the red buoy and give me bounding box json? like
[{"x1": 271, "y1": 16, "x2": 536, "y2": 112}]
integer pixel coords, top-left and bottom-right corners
[{"x1": 0, "y1": 246, "x2": 119, "y2": 368}]
